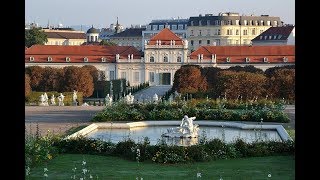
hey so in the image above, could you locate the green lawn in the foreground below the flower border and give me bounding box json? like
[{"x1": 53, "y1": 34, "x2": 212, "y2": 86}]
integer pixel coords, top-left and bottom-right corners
[{"x1": 30, "y1": 154, "x2": 295, "y2": 180}]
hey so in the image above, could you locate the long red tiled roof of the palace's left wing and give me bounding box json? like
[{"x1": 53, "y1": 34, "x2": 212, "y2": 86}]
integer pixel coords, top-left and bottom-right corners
[{"x1": 25, "y1": 45, "x2": 141, "y2": 63}]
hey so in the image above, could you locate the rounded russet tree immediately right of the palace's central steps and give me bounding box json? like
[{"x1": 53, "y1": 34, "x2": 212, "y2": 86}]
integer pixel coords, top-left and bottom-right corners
[{"x1": 172, "y1": 65, "x2": 208, "y2": 93}]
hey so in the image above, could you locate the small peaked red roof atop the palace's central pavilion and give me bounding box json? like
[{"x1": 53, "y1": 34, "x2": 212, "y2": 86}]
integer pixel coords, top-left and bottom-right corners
[{"x1": 149, "y1": 28, "x2": 182, "y2": 45}]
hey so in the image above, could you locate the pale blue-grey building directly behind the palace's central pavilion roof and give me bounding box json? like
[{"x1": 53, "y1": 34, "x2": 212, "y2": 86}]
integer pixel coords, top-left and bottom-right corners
[{"x1": 141, "y1": 18, "x2": 188, "y2": 51}]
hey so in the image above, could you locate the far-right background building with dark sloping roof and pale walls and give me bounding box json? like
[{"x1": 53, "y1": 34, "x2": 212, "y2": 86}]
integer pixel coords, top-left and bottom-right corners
[{"x1": 252, "y1": 25, "x2": 295, "y2": 46}]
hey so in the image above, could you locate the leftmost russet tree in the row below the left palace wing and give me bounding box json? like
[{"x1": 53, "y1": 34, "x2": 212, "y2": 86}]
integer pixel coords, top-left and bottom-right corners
[{"x1": 25, "y1": 66, "x2": 44, "y2": 91}]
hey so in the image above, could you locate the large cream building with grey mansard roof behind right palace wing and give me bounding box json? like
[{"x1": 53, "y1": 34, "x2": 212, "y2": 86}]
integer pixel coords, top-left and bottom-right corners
[{"x1": 187, "y1": 12, "x2": 282, "y2": 51}]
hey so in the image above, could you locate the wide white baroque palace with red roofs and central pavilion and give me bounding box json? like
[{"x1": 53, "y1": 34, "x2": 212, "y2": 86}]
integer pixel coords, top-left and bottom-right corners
[{"x1": 25, "y1": 28, "x2": 295, "y2": 86}]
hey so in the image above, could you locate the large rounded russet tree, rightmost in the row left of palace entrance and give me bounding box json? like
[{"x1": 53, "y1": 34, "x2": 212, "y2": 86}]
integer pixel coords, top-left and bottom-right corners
[{"x1": 63, "y1": 66, "x2": 94, "y2": 97}]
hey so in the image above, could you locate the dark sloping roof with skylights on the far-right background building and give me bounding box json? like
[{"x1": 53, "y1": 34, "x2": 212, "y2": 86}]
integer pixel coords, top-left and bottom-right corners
[{"x1": 252, "y1": 26, "x2": 294, "y2": 41}]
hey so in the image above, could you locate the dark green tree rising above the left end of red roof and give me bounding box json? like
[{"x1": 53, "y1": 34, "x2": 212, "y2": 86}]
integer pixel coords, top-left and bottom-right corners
[{"x1": 24, "y1": 27, "x2": 48, "y2": 47}]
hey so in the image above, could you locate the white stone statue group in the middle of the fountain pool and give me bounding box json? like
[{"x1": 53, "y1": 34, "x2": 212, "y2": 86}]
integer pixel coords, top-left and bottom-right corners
[{"x1": 162, "y1": 115, "x2": 199, "y2": 138}]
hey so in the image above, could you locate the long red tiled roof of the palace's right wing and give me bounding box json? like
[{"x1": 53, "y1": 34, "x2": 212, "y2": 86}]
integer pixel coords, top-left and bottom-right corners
[{"x1": 190, "y1": 45, "x2": 295, "y2": 63}]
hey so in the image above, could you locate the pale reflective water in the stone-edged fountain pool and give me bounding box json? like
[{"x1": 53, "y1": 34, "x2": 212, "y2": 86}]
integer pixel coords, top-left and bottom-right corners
[{"x1": 87, "y1": 126, "x2": 281, "y2": 146}]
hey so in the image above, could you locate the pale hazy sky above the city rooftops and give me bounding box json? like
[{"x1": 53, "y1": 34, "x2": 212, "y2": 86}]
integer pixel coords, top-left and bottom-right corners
[{"x1": 25, "y1": 0, "x2": 295, "y2": 28}]
